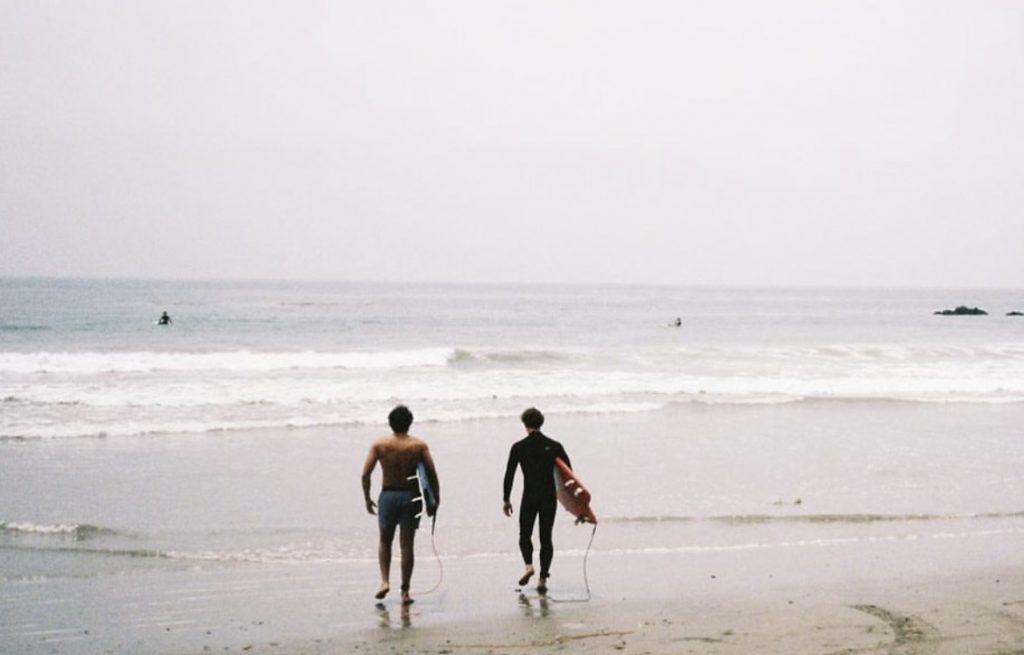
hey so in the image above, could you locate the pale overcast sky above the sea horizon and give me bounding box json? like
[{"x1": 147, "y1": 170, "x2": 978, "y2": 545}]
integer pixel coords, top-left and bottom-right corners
[{"x1": 0, "y1": 0, "x2": 1024, "y2": 288}]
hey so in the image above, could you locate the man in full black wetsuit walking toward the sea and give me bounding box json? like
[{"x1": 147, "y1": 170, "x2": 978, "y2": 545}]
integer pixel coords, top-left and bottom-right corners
[{"x1": 502, "y1": 407, "x2": 572, "y2": 594}]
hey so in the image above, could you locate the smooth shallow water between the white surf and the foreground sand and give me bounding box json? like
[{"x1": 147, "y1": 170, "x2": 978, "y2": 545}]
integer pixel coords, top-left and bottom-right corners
[{"x1": 0, "y1": 401, "x2": 1024, "y2": 579}]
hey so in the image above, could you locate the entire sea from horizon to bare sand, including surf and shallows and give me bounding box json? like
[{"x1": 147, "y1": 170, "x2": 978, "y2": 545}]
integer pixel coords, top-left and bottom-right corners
[{"x1": 0, "y1": 278, "x2": 1024, "y2": 653}]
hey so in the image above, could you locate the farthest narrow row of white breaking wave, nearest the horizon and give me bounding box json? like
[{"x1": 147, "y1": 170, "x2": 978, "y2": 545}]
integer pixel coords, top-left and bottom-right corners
[{"x1": 0, "y1": 343, "x2": 1024, "y2": 376}]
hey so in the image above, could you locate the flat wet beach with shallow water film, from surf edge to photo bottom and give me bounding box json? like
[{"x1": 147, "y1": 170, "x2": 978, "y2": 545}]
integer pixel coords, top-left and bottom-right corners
[{"x1": 0, "y1": 402, "x2": 1024, "y2": 654}]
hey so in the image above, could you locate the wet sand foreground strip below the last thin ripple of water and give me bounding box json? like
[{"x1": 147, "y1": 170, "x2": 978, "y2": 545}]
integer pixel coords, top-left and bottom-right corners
[{"x1": 3, "y1": 511, "x2": 1024, "y2": 655}]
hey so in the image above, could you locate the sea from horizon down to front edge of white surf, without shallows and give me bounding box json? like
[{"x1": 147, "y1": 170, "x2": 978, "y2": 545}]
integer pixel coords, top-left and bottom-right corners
[{"x1": 0, "y1": 279, "x2": 1024, "y2": 439}]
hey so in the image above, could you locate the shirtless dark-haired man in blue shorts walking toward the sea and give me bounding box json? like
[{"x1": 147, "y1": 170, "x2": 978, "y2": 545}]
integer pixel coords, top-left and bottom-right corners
[{"x1": 362, "y1": 405, "x2": 441, "y2": 605}]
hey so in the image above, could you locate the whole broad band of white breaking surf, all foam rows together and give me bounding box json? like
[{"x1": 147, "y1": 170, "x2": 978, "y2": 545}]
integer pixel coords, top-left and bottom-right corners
[{"x1": 0, "y1": 343, "x2": 1024, "y2": 439}]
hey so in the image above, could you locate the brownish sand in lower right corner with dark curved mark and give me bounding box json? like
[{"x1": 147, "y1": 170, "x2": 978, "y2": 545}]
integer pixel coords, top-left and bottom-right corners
[{"x1": 266, "y1": 556, "x2": 1024, "y2": 655}]
